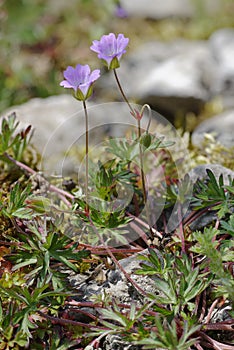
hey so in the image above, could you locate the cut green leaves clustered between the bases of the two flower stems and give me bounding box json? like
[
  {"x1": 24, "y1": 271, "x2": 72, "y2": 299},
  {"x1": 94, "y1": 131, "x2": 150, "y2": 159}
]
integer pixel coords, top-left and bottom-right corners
[{"x1": 73, "y1": 154, "x2": 139, "y2": 231}]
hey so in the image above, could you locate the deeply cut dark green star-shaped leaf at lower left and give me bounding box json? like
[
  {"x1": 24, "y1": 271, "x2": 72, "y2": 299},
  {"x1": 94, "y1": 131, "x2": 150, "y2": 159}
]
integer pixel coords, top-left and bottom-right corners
[{"x1": 8, "y1": 217, "x2": 89, "y2": 290}]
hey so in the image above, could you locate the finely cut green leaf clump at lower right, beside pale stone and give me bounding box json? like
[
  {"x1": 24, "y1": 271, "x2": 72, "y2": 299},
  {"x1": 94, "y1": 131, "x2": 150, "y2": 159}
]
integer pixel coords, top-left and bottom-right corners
[{"x1": 136, "y1": 249, "x2": 212, "y2": 316}]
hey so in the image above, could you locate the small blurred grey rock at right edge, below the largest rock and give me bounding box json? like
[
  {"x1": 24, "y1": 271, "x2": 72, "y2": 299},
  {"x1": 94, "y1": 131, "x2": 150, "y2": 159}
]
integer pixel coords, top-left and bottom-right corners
[{"x1": 192, "y1": 109, "x2": 234, "y2": 148}]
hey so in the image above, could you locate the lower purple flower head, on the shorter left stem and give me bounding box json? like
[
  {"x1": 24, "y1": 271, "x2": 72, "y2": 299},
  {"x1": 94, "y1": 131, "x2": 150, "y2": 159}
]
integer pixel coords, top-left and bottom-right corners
[{"x1": 60, "y1": 64, "x2": 100, "y2": 101}]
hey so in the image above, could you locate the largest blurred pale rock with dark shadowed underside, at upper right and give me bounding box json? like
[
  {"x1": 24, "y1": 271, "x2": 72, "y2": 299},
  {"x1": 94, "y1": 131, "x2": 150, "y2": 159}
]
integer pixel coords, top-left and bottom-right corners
[{"x1": 99, "y1": 28, "x2": 234, "y2": 119}]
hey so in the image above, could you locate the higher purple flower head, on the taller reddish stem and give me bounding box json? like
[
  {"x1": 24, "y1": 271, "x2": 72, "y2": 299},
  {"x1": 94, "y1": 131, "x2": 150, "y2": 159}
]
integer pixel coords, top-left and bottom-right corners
[{"x1": 90, "y1": 33, "x2": 129, "y2": 69}]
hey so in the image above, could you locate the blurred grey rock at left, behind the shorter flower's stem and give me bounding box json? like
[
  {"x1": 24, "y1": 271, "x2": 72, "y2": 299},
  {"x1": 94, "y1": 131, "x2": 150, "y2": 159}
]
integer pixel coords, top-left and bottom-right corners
[{"x1": 1, "y1": 94, "x2": 152, "y2": 175}]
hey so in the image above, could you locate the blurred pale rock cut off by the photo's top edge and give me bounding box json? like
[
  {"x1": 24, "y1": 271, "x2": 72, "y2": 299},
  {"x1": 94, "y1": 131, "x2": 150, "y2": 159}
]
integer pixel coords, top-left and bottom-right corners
[{"x1": 120, "y1": 0, "x2": 220, "y2": 19}]
